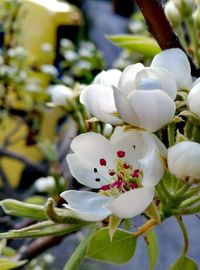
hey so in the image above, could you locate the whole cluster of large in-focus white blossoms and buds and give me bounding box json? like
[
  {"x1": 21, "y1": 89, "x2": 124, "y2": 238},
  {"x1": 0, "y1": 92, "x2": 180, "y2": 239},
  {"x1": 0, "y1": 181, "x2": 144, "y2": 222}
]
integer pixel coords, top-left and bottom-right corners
[{"x1": 57, "y1": 49, "x2": 200, "y2": 221}]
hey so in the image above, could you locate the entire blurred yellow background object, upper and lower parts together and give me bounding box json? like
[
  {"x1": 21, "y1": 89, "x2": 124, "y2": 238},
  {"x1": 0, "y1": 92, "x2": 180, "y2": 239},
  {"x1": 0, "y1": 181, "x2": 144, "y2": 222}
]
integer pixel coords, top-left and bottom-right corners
[{"x1": 0, "y1": 0, "x2": 83, "y2": 187}]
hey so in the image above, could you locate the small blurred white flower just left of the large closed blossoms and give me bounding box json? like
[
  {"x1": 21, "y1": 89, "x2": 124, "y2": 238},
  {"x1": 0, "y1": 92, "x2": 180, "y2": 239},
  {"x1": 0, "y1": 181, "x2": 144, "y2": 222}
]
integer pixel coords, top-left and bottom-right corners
[{"x1": 47, "y1": 84, "x2": 73, "y2": 106}]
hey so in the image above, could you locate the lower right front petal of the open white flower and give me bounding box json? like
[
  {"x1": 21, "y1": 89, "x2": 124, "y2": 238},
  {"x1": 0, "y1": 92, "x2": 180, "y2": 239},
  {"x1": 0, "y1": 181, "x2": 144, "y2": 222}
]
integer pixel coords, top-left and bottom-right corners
[{"x1": 106, "y1": 187, "x2": 154, "y2": 218}]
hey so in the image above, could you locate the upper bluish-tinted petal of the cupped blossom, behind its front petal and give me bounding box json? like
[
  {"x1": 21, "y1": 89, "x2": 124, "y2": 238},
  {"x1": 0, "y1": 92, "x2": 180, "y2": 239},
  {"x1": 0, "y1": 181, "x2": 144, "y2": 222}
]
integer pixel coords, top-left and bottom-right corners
[{"x1": 135, "y1": 67, "x2": 177, "y2": 100}]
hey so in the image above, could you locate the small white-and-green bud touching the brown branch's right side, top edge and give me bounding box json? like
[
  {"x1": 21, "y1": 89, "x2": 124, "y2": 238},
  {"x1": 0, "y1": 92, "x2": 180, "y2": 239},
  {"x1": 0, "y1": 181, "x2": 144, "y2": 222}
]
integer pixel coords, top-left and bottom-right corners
[{"x1": 165, "y1": 1, "x2": 181, "y2": 27}]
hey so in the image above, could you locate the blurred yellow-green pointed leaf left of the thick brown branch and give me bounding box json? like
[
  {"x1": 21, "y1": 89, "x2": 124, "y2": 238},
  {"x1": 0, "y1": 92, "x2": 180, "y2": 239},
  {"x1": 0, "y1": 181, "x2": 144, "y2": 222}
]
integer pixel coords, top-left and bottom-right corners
[{"x1": 107, "y1": 35, "x2": 161, "y2": 57}]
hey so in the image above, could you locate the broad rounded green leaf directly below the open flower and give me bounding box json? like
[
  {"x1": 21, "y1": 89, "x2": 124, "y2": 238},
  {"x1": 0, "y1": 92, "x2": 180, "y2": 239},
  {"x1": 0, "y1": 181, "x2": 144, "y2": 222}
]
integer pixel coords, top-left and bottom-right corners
[{"x1": 87, "y1": 228, "x2": 137, "y2": 264}]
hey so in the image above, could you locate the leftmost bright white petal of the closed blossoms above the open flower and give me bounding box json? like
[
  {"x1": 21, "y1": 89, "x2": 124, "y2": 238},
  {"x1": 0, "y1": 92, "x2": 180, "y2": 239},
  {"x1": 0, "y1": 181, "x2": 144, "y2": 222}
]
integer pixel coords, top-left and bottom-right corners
[{"x1": 80, "y1": 84, "x2": 122, "y2": 125}]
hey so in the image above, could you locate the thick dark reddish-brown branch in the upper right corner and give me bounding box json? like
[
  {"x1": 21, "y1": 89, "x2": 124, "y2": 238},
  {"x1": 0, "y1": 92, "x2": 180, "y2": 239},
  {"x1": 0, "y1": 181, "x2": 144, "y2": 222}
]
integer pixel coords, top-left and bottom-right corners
[{"x1": 135, "y1": 0, "x2": 200, "y2": 77}]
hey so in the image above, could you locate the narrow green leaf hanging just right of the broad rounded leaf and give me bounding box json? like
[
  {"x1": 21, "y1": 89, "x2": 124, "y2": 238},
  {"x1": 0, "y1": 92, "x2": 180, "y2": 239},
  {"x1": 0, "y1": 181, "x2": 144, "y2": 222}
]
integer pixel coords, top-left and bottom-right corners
[{"x1": 145, "y1": 230, "x2": 158, "y2": 270}]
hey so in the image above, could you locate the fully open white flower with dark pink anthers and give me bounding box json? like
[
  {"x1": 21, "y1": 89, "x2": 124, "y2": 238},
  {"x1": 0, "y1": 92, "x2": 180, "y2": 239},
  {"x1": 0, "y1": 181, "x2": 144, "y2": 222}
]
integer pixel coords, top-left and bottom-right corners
[{"x1": 61, "y1": 127, "x2": 166, "y2": 221}]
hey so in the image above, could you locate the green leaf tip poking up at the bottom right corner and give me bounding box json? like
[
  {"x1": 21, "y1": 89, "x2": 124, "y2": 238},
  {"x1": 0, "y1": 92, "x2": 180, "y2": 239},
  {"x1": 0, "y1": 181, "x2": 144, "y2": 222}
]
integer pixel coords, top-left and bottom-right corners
[{"x1": 169, "y1": 255, "x2": 198, "y2": 270}]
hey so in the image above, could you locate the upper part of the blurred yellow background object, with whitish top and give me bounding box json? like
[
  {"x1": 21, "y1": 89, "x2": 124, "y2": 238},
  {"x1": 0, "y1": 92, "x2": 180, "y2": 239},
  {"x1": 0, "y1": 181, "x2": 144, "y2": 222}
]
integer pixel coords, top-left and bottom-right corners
[{"x1": 20, "y1": 0, "x2": 83, "y2": 64}]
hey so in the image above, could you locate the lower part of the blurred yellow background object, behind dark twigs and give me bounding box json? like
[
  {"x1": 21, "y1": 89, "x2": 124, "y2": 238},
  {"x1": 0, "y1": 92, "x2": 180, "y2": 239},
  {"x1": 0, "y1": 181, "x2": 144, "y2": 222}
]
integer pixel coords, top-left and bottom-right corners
[{"x1": 0, "y1": 108, "x2": 62, "y2": 187}]
